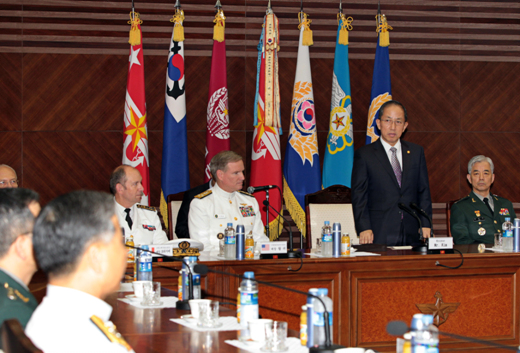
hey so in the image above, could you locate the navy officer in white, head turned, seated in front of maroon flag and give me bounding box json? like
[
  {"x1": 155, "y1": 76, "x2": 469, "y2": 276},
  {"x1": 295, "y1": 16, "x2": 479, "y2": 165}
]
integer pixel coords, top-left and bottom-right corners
[{"x1": 188, "y1": 151, "x2": 269, "y2": 251}]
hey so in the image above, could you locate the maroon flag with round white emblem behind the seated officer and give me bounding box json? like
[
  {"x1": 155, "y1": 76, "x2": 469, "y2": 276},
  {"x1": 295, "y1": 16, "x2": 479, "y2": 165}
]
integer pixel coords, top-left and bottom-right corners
[{"x1": 204, "y1": 40, "x2": 229, "y2": 182}]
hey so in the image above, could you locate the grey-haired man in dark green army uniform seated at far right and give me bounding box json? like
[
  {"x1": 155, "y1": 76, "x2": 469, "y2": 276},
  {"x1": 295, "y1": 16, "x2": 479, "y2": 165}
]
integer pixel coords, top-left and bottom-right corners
[{"x1": 450, "y1": 155, "x2": 516, "y2": 244}]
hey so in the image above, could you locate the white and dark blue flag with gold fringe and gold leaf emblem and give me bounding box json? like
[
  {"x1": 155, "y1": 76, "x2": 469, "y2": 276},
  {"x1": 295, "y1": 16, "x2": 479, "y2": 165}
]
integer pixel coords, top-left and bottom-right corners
[{"x1": 283, "y1": 17, "x2": 321, "y2": 235}]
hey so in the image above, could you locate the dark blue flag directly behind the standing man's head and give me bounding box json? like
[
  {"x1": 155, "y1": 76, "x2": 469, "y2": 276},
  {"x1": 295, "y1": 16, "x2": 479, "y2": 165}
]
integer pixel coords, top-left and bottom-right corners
[{"x1": 366, "y1": 11, "x2": 392, "y2": 145}]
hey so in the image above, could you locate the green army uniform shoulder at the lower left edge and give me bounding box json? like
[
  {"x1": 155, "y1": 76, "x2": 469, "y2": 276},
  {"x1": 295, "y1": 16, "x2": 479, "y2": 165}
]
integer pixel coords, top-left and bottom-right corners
[{"x1": 0, "y1": 270, "x2": 38, "y2": 348}]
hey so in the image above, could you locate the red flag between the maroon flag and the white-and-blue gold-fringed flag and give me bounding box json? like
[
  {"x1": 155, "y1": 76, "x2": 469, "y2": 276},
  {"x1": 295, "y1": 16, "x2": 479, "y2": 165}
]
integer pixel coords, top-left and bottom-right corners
[{"x1": 250, "y1": 24, "x2": 283, "y2": 240}]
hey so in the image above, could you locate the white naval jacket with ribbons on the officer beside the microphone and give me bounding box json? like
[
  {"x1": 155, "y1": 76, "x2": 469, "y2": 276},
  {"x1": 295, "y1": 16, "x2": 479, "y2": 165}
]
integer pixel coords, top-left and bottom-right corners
[{"x1": 188, "y1": 184, "x2": 269, "y2": 251}]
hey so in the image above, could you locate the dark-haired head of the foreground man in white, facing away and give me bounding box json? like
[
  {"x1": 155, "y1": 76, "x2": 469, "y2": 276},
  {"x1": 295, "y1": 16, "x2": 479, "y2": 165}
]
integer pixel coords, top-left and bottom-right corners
[{"x1": 34, "y1": 190, "x2": 126, "y2": 298}]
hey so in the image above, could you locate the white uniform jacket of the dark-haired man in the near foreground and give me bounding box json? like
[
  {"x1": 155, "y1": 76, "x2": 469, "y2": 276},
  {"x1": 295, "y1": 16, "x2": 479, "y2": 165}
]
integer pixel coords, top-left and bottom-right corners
[{"x1": 25, "y1": 285, "x2": 134, "y2": 353}]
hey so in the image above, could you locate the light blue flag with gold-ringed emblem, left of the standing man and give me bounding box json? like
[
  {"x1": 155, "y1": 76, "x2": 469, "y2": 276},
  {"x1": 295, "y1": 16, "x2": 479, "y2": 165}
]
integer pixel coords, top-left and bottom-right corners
[{"x1": 323, "y1": 14, "x2": 354, "y2": 188}]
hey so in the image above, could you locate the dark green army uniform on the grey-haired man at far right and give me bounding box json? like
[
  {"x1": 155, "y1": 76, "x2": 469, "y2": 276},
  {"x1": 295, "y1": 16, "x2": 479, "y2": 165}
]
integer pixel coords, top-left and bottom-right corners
[{"x1": 450, "y1": 191, "x2": 516, "y2": 244}]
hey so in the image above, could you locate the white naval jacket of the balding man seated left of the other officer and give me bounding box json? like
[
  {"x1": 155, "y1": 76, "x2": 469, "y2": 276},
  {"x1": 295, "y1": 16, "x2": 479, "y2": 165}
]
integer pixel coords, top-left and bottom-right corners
[{"x1": 114, "y1": 199, "x2": 168, "y2": 245}]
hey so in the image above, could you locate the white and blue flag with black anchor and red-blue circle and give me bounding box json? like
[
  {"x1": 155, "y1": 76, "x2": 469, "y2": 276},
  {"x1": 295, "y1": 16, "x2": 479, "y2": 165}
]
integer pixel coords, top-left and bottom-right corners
[{"x1": 161, "y1": 16, "x2": 190, "y2": 227}]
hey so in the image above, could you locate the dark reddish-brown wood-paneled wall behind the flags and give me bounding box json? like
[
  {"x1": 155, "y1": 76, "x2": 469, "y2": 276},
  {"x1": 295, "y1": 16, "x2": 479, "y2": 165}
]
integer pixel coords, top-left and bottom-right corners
[{"x1": 0, "y1": 0, "x2": 520, "y2": 212}]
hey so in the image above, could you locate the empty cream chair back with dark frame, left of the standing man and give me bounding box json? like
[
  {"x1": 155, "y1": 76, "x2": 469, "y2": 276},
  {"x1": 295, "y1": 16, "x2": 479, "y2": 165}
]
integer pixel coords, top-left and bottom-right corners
[{"x1": 305, "y1": 185, "x2": 359, "y2": 249}]
